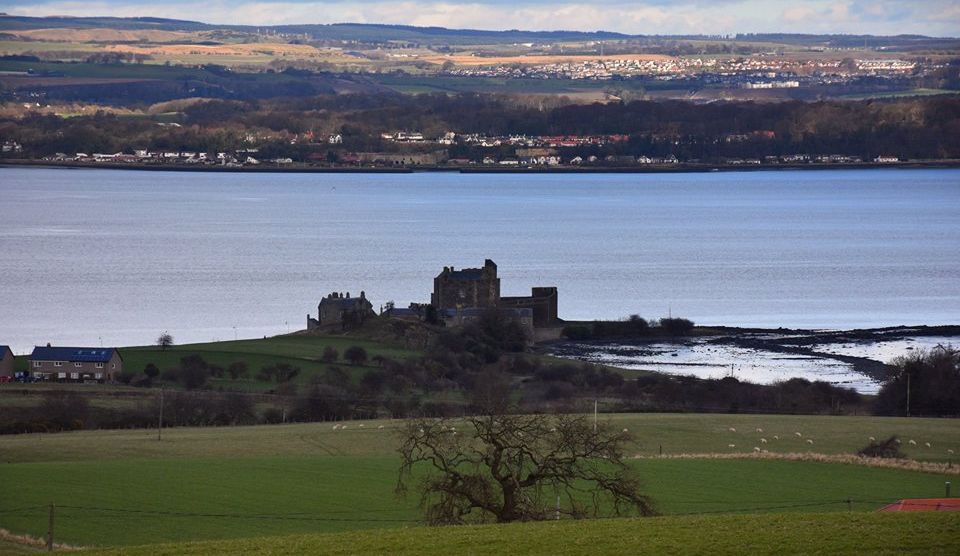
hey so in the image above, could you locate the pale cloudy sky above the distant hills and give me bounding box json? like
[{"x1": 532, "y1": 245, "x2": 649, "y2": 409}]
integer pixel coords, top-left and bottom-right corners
[{"x1": 0, "y1": 0, "x2": 960, "y2": 37}]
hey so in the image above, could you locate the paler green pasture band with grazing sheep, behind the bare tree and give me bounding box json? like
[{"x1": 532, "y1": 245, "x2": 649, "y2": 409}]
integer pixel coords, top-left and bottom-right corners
[{"x1": 0, "y1": 413, "x2": 960, "y2": 465}]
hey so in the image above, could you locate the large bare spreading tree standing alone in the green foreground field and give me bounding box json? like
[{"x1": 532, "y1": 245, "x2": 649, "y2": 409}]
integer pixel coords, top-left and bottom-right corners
[{"x1": 397, "y1": 412, "x2": 655, "y2": 525}]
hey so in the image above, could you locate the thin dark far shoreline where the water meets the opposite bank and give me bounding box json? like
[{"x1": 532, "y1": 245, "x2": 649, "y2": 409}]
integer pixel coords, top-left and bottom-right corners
[{"x1": 0, "y1": 159, "x2": 960, "y2": 174}]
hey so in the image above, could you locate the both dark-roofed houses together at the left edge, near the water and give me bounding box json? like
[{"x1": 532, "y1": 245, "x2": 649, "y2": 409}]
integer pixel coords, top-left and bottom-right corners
[{"x1": 0, "y1": 344, "x2": 123, "y2": 383}]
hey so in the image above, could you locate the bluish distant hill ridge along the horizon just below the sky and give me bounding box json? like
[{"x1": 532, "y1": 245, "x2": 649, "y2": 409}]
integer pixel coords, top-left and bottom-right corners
[{"x1": 0, "y1": 15, "x2": 960, "y2": 48}]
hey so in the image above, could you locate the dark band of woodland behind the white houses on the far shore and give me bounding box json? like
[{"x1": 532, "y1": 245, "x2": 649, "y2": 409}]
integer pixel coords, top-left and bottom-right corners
[{"x1": 0, "y1": 94, "x2": 960, "y2": 162}]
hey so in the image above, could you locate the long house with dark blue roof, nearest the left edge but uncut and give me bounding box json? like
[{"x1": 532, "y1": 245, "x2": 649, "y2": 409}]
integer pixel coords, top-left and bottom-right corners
[{"x1": 29, "y1": 344, "x2": 123, "y2": 382}]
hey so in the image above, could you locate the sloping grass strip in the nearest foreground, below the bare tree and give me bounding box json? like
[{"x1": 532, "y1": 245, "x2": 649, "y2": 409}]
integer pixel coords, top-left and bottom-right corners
[{"x1": 82, "y1": 514, "x2": 960, "y2": 556}]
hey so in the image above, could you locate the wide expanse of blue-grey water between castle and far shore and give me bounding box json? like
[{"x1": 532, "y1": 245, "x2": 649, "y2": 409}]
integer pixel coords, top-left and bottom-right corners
[{"x1": 0, "y1": 168, "x2": 960, "y2": 353}]
